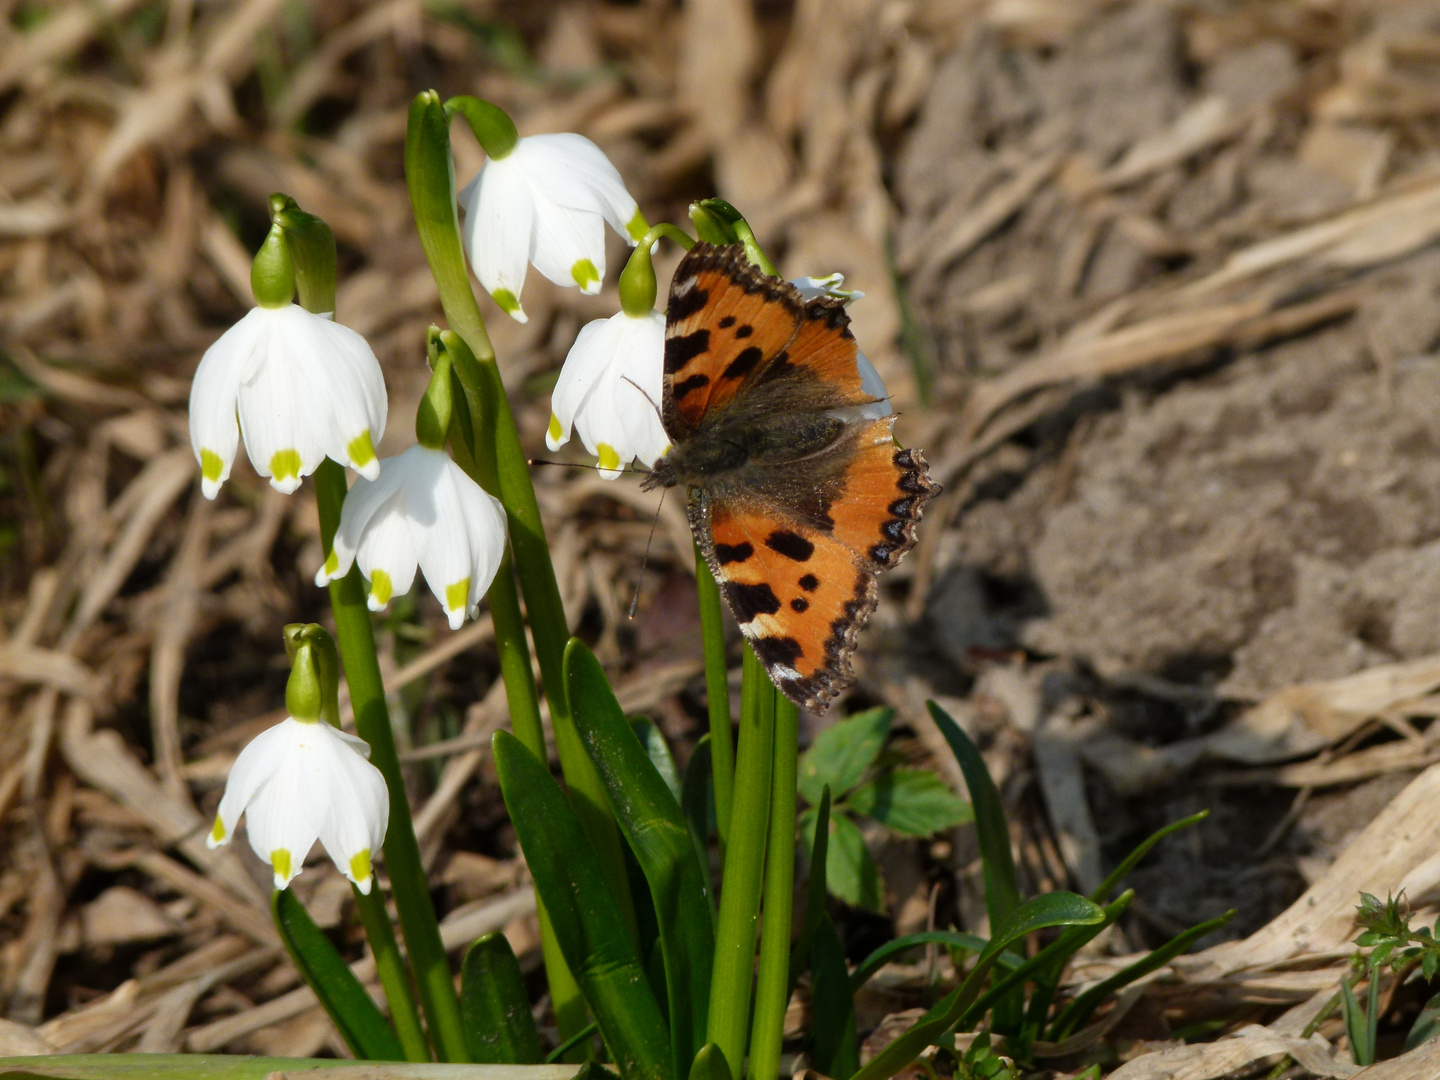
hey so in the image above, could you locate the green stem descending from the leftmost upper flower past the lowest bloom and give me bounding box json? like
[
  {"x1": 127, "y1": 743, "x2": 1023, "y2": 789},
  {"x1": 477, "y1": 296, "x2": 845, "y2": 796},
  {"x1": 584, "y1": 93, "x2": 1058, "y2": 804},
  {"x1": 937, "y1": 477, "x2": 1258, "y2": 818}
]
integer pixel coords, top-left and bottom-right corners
[{"x1": 315, "y1": 458, "x2": 469, "y2": 1061}]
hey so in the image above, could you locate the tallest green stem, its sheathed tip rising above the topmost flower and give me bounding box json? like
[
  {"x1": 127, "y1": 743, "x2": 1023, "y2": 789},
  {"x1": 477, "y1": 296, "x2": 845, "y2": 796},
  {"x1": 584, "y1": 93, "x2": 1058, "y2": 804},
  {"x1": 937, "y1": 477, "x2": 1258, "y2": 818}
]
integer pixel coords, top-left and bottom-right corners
[{"x1": 405, "y1": 91, "x2": 639, "y2": 956}]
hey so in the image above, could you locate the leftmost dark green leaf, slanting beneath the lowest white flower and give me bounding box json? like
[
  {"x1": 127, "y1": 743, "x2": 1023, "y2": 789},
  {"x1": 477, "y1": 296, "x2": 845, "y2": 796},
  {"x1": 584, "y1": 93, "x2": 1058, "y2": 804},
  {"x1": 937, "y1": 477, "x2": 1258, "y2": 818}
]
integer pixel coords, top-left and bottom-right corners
[{"x1": 271, "y1": 888, "x2": 405, "y2": 1061}]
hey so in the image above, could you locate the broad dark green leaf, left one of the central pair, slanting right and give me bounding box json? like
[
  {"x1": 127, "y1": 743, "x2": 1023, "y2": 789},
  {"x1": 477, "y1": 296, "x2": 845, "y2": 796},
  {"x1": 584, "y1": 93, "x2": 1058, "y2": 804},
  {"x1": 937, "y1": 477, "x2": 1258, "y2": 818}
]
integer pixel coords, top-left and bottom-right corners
[{"x1": 491, "y1": 729, "x2": 674, "y2": 1080}]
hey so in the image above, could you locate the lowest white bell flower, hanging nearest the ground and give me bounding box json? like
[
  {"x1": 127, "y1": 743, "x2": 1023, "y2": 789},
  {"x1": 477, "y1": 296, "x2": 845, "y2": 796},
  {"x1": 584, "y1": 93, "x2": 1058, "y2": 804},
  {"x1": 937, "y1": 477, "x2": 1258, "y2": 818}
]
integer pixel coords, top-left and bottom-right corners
[{"x1": 206, "y1": 717, "x2": 390, "y2": 893}]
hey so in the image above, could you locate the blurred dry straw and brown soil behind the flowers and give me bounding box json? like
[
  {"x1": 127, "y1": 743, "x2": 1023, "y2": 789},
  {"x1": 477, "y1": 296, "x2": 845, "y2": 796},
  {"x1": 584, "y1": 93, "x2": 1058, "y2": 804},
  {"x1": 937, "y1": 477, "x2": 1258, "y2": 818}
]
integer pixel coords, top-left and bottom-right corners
[{"x1": 8, "y1": 0, "x2": 1440, "y2": 1054}]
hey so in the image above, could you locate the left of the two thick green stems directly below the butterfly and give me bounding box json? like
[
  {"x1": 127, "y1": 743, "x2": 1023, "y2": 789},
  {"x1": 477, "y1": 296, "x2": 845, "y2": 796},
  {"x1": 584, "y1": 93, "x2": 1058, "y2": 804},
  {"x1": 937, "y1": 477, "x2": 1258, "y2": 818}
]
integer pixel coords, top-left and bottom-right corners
[{"x1": 706, "y1": 647, "x2": 793, "y2": 1080}]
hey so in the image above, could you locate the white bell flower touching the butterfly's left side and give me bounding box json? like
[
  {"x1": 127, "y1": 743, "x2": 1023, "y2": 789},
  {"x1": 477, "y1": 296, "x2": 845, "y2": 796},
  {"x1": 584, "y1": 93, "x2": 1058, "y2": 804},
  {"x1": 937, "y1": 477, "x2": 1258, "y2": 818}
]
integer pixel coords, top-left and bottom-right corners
[{"x1": 544, "y1": 311, "x2": 670, "y2": 480}]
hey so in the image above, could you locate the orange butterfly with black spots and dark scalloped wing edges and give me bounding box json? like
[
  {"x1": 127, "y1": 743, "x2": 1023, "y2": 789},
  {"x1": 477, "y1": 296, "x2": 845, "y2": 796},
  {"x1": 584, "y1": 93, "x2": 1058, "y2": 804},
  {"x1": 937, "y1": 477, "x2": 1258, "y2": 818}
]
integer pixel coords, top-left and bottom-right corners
[{"x1": 642, "y1": 243, "x2": 940, "y2": 711}]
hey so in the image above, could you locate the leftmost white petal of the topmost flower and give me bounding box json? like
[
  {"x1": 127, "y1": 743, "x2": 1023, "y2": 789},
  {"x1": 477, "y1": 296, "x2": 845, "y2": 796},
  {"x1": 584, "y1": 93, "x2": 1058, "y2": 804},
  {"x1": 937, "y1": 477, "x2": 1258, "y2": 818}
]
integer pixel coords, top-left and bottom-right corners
[{"x1": 462, "y1": 154, "x2": 534, "y2": 323}]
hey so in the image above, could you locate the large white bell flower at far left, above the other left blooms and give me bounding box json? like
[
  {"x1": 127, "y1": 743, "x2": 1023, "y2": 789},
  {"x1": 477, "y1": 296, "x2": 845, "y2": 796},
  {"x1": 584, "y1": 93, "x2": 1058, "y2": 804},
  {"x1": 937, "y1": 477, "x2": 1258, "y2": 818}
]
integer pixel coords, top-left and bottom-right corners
[{"x1": 190, "y1": 304, "x2": 386, "y2": 498}]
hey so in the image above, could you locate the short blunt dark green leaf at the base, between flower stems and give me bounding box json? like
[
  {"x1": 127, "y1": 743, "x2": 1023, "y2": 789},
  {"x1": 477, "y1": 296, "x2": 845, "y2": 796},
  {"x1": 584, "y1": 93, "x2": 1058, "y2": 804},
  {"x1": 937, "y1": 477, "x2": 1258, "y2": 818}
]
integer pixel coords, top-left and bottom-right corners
[{"x1": 459, "y1": 933, "x2": 544, "y2": 1066}]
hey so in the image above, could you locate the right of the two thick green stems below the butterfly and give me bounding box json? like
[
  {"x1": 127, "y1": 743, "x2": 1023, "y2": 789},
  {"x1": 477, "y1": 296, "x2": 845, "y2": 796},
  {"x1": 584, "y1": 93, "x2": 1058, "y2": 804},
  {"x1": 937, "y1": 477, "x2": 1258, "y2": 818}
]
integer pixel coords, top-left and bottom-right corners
[{"x1": 749, "y1": 685, "x2": 799, "y2": 1080}]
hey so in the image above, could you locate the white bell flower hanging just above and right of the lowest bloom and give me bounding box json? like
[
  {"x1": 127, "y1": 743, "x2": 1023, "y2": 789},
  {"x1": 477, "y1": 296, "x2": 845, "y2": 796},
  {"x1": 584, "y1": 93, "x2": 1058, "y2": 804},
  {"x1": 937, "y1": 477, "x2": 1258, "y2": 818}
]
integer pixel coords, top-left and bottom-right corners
[{"x1": 315, "y1": 445, "x2": 505, "y2": 629}]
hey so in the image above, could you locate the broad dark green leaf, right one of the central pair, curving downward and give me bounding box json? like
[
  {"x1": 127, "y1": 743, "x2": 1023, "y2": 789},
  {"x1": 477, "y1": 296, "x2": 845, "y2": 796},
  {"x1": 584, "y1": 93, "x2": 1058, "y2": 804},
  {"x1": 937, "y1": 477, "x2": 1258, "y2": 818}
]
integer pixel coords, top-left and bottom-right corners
[{"x1": 564, "y1": 641, "x2": 714, "y2": 1076}]
